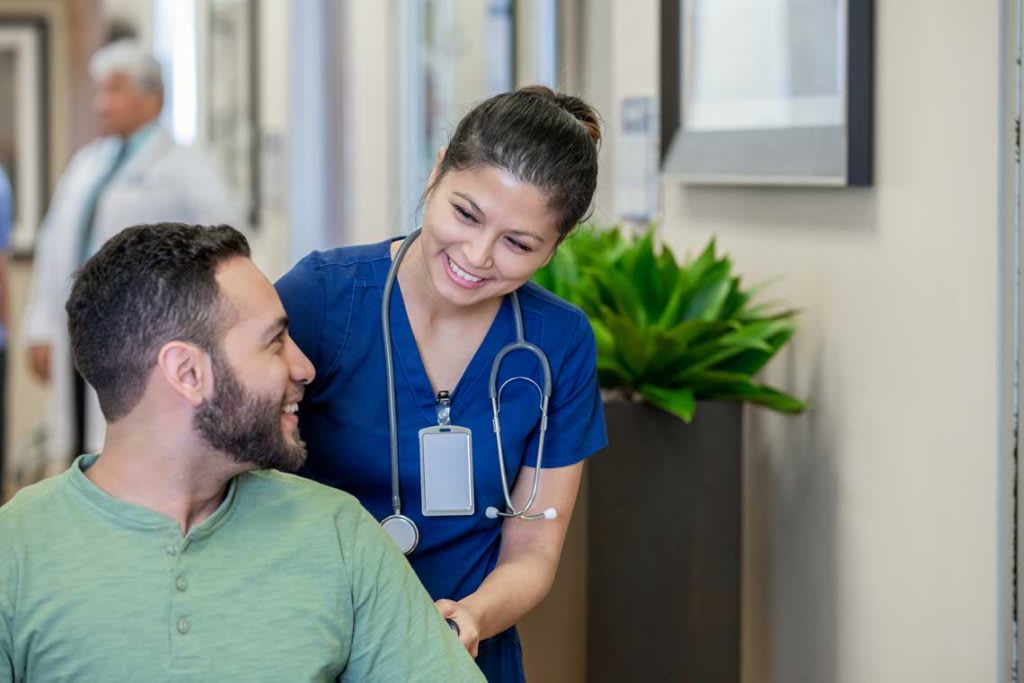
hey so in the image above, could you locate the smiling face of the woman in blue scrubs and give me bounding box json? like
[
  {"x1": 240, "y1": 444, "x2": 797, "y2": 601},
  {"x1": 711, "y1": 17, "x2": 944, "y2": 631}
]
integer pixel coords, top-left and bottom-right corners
[{"x1": 419, "y1": 166, "x2": 558, "y2": 305}]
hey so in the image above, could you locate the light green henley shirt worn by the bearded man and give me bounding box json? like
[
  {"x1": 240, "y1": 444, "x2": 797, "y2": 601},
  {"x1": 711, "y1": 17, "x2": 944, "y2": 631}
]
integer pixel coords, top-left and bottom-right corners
[{"x1": 0, "y1": 456, "x2": 483, "y2": 683}]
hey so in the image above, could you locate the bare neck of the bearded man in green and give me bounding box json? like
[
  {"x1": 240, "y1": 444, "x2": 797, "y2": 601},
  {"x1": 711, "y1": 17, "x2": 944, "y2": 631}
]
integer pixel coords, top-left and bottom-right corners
[{"x1": 85, "y1": 424, "x2": 251, "y2": 536}]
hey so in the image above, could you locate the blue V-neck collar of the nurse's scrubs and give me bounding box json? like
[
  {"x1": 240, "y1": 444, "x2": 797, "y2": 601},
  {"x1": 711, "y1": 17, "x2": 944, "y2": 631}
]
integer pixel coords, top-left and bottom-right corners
[{"x1": 374, "y1": 238, "x2": 513, "y2": 422}]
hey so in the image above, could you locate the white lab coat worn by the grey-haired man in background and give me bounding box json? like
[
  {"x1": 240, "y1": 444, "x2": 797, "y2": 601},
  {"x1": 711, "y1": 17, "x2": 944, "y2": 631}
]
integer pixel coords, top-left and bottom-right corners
[{"x1": 24, "y1": 129, "x2": 245, "y2": 465}]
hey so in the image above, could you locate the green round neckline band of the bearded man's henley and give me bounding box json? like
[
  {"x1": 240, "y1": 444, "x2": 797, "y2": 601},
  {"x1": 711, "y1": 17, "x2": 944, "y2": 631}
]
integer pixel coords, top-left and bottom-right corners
[{"x1": 62, "y1": 454, "x2": 239, "y2": 540}]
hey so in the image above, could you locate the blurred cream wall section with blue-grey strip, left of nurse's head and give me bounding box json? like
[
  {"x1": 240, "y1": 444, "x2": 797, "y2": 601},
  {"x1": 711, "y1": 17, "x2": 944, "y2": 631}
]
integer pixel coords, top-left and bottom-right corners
[{"x1": 192, "y1": 0, "x2": 399, "y2": 272}]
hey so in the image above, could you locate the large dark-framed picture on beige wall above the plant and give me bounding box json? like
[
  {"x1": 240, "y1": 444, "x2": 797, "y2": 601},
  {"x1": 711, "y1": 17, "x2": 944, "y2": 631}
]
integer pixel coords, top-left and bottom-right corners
[{"x1": 662, "y1": 0, "x2": 873, "y2": 186}]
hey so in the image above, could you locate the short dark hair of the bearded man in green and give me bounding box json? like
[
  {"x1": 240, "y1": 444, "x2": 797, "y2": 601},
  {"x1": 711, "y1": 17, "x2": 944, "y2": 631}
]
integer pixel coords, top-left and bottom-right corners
[{"x1": 66, "y1": 223, "x2": 251, "y2": 422}]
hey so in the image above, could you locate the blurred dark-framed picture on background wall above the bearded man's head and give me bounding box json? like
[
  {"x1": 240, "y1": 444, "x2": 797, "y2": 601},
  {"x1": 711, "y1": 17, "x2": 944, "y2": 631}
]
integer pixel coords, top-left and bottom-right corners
[{"x1": 204, "y1": 0, "x2": 260, "y2": 227}]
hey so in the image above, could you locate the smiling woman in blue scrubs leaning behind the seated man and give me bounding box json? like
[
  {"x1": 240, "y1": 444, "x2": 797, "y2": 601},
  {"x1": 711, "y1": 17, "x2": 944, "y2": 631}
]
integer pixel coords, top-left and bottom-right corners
[{"x1": 278, "y1": 86, "x2": 606, "y2": 681}]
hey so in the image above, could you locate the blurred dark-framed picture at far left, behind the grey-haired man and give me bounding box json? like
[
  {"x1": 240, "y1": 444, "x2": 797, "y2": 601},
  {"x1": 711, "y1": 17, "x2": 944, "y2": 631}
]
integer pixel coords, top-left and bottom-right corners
[{"x1": 0, "y1": 16, "x2": 50, "y2": 256}]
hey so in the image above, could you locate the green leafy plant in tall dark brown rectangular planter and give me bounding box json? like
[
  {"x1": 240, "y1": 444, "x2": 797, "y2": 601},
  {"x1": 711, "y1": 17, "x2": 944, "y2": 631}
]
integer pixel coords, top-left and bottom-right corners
[{"x1": 536, "y1": 227, "x2": 805, "y2": 683}]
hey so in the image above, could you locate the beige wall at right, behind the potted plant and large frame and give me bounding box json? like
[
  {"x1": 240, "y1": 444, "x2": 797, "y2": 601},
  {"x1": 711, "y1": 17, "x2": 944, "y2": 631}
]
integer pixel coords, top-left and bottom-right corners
[{"x1": 602, "y1": 0, "x2": 1006, "y2": 683}]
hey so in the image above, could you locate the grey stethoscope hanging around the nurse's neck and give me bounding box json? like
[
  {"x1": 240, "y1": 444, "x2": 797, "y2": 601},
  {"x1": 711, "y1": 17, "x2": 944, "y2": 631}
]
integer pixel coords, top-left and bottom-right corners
[{"x1": 381, "y1": 226, "x2": 558, "y2": 555}]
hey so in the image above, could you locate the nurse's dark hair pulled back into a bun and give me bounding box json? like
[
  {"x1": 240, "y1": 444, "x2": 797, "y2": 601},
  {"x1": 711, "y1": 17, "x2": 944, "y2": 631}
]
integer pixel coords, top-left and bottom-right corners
[{"x1": 427, "y1": 85, "x2": 601, "y2": 240}]
